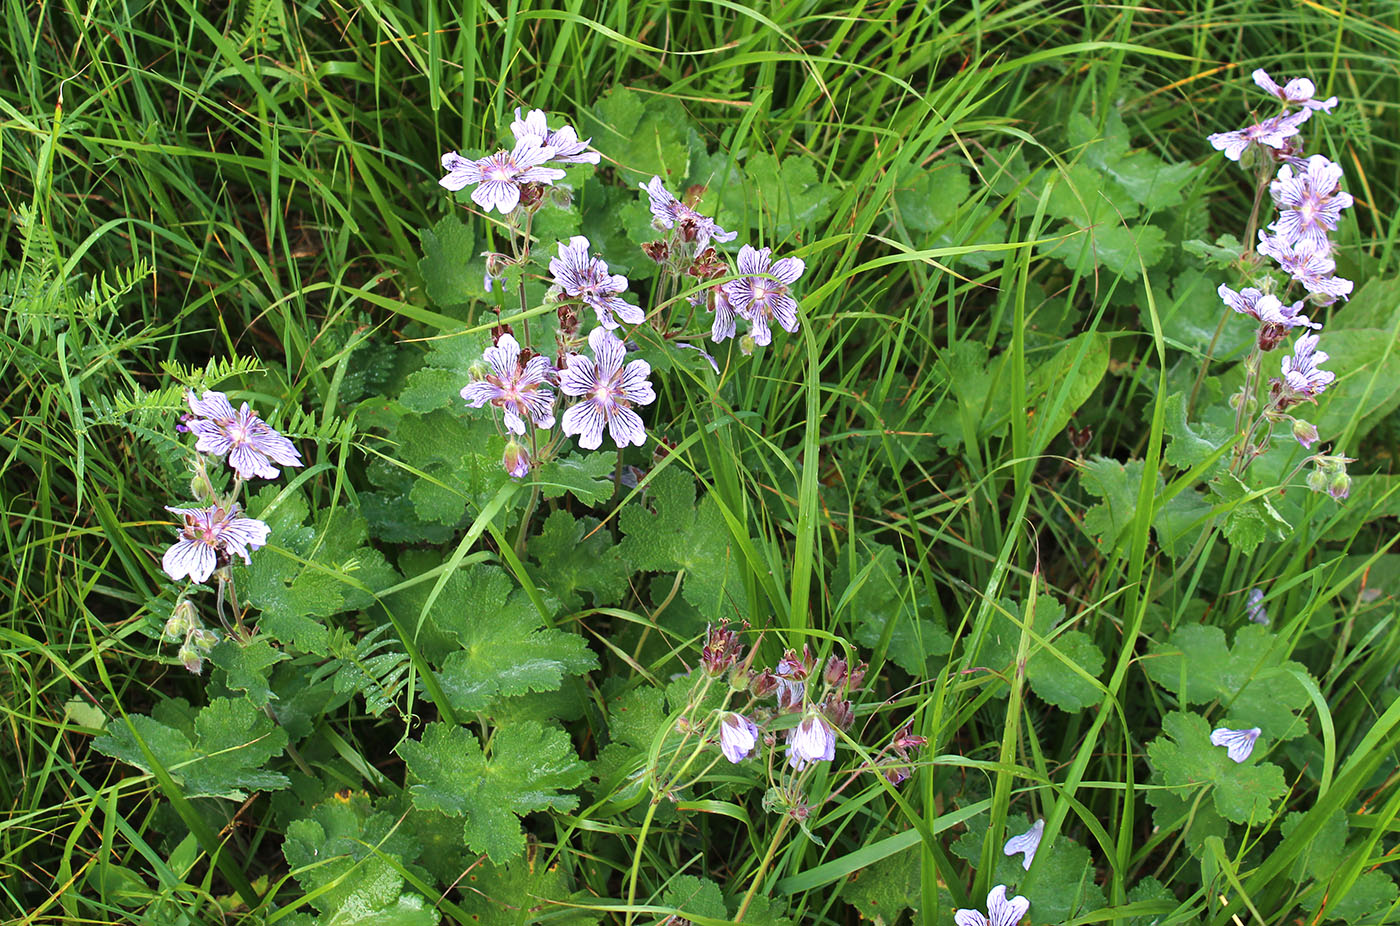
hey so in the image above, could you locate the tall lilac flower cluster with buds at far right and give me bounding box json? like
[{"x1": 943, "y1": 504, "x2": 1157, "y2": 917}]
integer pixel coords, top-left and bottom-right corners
[{"x1": 1210, "y1": 70, "x2": 1354, "y2": 495}]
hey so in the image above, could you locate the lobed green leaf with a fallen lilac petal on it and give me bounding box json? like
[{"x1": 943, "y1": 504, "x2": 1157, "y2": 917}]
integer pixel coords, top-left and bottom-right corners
[{"x1": 1147, "y1": 710, "x2": 1288, "y2": 824}]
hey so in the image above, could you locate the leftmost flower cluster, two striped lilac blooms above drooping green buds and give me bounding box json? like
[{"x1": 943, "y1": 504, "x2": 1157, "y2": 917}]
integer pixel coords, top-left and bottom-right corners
[{"x1": 161, "y1": 391, "x2": 301, "y2": 674}]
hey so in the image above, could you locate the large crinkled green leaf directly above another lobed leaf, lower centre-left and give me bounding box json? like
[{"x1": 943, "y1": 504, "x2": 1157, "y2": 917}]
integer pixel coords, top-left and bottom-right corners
[{"x1": 433, "y1": 565, "x2": 596, "y2": 712}]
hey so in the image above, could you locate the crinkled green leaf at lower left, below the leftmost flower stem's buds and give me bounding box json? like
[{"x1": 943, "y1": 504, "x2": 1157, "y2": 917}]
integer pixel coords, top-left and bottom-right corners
[{"x1": 92, "y1": 698, "x2": 288, "y2": 800}]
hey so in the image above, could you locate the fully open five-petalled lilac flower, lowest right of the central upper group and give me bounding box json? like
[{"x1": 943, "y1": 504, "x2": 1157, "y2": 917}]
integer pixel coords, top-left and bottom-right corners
[{"x1": 559, "y1": 328, "x2": 657, "y2": 450}]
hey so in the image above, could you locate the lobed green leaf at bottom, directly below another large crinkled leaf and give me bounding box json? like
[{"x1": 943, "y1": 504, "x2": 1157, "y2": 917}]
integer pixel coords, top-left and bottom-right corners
[{"x1": 398, "y1": 721, "x2": 588, "y2": 864}]
